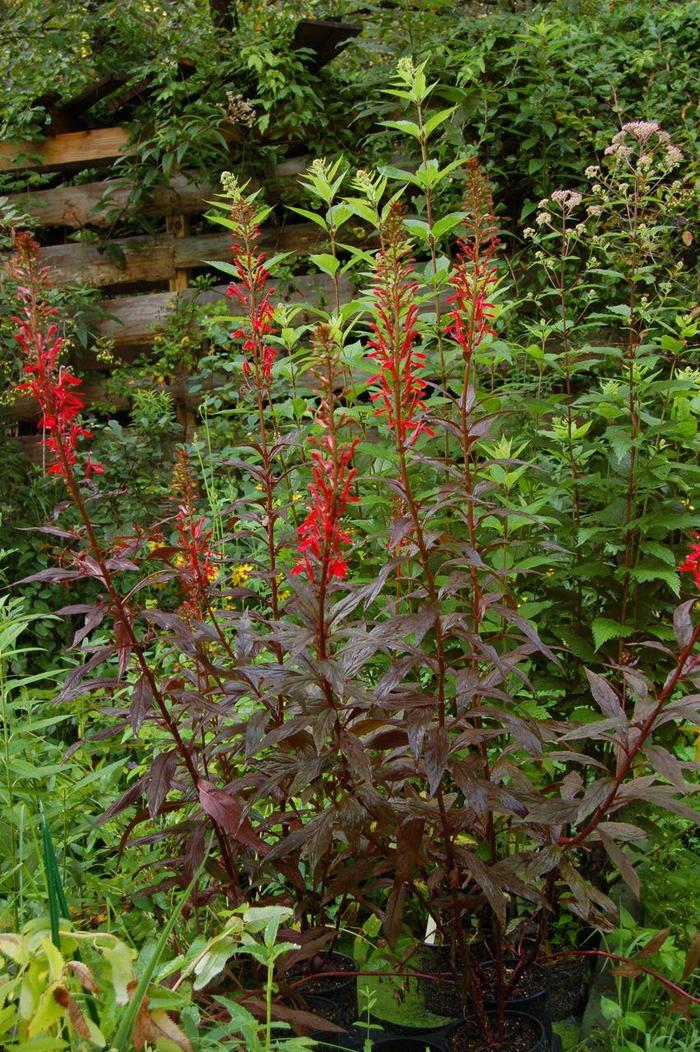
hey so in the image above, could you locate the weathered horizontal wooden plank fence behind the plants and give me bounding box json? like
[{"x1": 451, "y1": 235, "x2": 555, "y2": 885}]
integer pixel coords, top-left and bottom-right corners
[{"x1": 0, "y1": 127, "x2": 351, "y2": 439}]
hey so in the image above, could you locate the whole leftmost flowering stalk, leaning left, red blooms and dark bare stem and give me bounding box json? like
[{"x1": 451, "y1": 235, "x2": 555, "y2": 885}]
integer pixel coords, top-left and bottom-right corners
[{"x1": 13, "y1": 235, "x2": 240, "y2": 899}]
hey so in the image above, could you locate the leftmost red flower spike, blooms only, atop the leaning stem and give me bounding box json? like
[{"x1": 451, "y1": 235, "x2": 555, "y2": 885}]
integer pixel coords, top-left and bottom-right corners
[{"x1": 9, "y1": 232, "x2": 104, "y2": 478}]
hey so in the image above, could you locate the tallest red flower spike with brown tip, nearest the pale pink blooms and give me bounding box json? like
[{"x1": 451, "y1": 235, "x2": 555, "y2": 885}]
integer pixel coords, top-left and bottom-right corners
[{"x1": 445, "y1": 158, "x2": 499, "y2": 361}]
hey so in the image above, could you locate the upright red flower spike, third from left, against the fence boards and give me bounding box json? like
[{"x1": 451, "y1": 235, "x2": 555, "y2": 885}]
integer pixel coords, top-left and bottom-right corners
[{"x1": 226, "y1": 196, "x2": 277, "y2": 384}]
